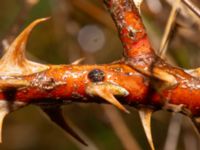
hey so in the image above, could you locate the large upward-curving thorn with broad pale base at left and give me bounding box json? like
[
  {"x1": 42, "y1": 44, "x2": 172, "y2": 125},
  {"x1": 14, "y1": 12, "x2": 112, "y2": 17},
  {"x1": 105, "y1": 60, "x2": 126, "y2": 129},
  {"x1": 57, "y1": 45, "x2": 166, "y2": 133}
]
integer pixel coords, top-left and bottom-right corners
[{"x1": 0, "y1": 18, "x2": 49, "y2": 76}]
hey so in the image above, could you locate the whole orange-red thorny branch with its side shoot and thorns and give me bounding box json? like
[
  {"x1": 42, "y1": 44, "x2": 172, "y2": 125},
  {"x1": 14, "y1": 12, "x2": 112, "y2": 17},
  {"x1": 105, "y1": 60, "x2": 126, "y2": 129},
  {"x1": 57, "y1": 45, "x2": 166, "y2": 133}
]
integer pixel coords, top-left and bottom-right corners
[{"x1": 0, "y1": 0, "x2": 200, "y2": 149}]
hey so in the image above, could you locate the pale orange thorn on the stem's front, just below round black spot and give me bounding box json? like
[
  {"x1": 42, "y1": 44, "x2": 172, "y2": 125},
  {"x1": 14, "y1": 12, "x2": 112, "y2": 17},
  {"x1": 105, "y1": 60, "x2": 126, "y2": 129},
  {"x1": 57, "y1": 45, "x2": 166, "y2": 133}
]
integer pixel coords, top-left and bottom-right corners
[{"x1": 86, "y1": 82, "x2": 130, "y2": 113}]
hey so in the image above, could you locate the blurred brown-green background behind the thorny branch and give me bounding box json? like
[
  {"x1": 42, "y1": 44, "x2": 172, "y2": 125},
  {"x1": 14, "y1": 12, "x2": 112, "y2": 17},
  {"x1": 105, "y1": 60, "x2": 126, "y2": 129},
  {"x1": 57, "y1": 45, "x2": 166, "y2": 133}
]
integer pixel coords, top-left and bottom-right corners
[{"x1": 0, "y1": 0, "x2": 200, "y2": 150}]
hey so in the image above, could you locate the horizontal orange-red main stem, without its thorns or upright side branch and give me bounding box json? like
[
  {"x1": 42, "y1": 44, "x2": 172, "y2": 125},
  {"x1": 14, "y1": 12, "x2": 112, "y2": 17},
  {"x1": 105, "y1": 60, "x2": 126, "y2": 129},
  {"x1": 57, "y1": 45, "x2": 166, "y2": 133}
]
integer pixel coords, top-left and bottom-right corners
[{"x1": 0, "y1": 64, "x2": 200, "y2": 115}]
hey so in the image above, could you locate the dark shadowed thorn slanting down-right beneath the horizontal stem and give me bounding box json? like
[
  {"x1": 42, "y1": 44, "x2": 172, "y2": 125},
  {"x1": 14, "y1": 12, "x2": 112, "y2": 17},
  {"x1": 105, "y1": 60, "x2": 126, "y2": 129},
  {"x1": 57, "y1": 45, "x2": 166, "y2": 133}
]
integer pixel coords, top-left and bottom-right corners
[{"x1": 42, "y1": 107, "x2": 88, "y2": 146}]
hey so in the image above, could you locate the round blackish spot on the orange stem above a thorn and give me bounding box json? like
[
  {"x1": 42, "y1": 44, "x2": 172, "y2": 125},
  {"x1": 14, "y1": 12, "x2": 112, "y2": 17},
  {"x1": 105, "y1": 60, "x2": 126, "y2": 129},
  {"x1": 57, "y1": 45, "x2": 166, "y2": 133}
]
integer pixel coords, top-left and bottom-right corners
[{"x1": 88, "y1": 69, "x2": 105, "y2": 82}]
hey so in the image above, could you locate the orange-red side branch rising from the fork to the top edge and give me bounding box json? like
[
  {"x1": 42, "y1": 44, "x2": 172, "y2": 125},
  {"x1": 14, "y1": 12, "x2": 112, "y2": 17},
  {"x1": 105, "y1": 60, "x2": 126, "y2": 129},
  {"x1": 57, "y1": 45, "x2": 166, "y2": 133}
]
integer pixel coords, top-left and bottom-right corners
[{"x1": 104, "y1": 0, "x2": 156, "y2": 69}]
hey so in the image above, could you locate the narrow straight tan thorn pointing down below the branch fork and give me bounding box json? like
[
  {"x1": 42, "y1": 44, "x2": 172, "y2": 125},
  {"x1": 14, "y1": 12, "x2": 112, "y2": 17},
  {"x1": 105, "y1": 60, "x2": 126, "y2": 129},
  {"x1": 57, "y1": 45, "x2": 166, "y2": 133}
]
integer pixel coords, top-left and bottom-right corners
[{"x1": 139, "y1": 108, "x2": 155, "y2": 150}]
